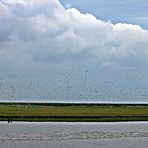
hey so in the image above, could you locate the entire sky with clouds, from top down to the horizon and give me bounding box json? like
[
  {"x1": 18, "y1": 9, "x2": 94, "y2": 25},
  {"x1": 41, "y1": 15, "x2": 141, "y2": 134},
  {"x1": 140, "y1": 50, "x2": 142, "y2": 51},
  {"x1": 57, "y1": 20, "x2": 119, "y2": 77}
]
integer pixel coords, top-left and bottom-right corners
[{"x1": 0, "y1": 0, "x2": 148, "y2": 103}]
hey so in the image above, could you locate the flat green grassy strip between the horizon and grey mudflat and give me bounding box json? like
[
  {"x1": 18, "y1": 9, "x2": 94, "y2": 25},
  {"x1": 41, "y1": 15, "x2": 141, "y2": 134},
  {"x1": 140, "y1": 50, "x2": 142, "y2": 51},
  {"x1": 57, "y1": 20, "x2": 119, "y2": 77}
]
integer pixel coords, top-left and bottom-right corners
[{"x1": 0, "y1": 103, "x2": 148, "y2": 121}]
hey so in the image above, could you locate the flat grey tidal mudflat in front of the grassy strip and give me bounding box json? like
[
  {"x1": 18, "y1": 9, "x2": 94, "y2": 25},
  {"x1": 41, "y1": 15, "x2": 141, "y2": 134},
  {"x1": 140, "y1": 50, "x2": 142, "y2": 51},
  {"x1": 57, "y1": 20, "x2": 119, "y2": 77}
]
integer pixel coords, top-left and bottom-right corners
[{"x1": 0, "y1": 122, "x2": 148, "y2": 148}]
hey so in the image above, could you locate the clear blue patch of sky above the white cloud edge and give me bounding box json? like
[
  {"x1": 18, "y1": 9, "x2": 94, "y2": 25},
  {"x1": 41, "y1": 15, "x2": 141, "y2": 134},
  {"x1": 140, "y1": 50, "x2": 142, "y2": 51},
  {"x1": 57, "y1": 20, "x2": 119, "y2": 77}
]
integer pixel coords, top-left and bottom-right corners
[{"x1": 61, "y1": 0, "x2": 148, "y2": 29}]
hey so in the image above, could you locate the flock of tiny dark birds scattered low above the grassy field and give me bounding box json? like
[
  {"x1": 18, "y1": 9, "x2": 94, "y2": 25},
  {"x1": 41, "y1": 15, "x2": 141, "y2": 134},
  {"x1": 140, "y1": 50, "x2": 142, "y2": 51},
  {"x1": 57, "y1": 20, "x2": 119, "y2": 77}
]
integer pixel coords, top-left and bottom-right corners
[{"x1": 0, "y1": 67, "x2": 148, "y2": 102}]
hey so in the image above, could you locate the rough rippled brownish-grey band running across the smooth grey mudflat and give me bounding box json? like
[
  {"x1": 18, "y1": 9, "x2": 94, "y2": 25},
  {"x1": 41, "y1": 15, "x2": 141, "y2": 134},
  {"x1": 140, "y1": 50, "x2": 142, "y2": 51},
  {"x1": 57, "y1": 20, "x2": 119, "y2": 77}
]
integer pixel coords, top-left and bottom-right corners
[{"x1": 0, "y1": 131, "x2": 148, "y2": 141}]
